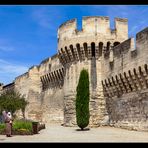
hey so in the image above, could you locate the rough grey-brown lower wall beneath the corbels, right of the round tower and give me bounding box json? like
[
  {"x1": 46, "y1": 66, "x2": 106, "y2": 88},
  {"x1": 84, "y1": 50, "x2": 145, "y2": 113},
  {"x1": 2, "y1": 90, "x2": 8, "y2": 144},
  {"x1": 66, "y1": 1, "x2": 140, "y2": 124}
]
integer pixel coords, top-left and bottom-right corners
[{"x1": 107, "y1": 89, "x2": 148, "y2": 131}]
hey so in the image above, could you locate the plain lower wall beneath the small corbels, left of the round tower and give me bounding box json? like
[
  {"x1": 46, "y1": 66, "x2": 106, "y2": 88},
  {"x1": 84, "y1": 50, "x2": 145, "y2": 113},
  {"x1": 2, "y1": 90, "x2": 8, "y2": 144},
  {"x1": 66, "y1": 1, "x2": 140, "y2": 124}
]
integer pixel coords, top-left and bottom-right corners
[{"x1": 41, "y1": 88, "x2": 64, "y2": 124}]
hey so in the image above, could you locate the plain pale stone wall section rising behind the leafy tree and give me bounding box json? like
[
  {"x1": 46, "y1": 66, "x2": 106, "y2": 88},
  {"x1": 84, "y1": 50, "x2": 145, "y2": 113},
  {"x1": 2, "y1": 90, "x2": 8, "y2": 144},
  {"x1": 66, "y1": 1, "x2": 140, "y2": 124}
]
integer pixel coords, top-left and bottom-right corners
[{"x1": 15, "y1": 66, "x2": 42, "y2": 121}]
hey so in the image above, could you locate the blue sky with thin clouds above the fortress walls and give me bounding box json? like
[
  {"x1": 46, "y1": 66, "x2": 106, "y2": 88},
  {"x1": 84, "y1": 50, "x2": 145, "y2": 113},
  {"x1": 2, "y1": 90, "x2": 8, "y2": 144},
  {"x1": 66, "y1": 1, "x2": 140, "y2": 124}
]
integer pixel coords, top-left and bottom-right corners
[{"x1": 0, "y1": 5, "x2": 148, "y2": 84}]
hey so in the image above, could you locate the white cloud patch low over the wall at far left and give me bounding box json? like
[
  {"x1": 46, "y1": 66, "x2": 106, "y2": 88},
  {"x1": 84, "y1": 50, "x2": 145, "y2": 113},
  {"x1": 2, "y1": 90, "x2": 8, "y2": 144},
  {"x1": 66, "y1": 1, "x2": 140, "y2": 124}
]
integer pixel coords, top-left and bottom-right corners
[{"x1": 0, "y1": 59, "x2": 28, "y2": 84}]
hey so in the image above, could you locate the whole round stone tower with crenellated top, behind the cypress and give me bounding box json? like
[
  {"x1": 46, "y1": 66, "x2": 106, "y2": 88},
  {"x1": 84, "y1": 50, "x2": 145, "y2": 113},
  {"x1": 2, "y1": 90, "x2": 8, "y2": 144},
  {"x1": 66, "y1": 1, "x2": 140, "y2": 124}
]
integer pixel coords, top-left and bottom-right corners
[{"x1": 58, "y1": 16, "x2": 128, "y2": 126}]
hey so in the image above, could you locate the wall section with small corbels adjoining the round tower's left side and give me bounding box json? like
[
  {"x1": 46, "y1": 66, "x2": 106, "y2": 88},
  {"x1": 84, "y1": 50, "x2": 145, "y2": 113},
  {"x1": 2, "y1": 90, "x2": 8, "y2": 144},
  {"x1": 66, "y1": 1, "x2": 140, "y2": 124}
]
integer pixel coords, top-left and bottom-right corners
[{"x1": 40, "y1": 55, "x2": 64, "y2": 124}]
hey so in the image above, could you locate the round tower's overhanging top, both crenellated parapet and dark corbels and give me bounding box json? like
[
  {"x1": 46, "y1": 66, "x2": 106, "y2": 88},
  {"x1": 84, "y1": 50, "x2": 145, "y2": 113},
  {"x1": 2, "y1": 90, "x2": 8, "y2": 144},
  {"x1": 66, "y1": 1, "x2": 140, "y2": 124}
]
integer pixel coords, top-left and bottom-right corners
[{"x1": 58, "y1": 16, "x2": 128, "y2": 65}]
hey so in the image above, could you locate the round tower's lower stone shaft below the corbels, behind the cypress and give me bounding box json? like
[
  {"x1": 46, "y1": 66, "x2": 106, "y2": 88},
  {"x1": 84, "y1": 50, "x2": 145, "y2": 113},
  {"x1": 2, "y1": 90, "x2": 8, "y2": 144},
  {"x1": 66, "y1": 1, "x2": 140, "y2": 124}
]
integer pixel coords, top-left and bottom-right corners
[{"x1": 64, "y1": 59, "x2": 105, "y2": 126}]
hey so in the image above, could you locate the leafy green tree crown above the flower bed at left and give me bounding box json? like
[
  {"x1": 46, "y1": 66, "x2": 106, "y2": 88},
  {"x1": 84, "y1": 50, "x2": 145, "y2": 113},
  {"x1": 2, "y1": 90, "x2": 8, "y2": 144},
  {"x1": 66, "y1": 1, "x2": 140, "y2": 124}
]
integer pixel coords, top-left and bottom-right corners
[{"x1": 0, "y1": 90, "x2": 28, "y2": 116}]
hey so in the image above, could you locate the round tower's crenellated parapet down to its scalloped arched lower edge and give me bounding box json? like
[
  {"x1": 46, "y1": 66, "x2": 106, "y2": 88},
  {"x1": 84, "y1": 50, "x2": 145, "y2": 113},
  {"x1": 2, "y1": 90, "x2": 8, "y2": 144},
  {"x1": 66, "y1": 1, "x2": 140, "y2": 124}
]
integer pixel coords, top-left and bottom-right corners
[{"x1": 57, "y1": 16, "x2": 128, "y2": 51}]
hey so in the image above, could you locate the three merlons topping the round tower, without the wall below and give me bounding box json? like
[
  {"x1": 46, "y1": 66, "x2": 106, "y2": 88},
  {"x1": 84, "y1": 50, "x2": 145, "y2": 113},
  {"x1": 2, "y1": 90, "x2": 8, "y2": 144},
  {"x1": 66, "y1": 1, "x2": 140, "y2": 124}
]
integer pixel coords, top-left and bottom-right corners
[{"x1": 58, "y1": 16, "x2": 128, "y2": 36}]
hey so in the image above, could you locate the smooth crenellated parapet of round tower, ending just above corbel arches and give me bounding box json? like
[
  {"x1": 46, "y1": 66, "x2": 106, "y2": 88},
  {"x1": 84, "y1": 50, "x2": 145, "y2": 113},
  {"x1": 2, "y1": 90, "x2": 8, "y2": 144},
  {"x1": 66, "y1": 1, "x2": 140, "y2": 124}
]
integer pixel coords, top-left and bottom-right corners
[{"x1": 58, "y1": 16, "x2": 128, "y2": 47}]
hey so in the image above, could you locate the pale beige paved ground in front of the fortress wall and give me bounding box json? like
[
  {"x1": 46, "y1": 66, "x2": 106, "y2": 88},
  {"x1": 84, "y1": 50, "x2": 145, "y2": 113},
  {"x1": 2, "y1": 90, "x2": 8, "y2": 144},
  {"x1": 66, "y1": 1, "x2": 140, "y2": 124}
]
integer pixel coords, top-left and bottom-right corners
[{"x1": 0, "y1": 125, "x2": 148, "y2": 143}]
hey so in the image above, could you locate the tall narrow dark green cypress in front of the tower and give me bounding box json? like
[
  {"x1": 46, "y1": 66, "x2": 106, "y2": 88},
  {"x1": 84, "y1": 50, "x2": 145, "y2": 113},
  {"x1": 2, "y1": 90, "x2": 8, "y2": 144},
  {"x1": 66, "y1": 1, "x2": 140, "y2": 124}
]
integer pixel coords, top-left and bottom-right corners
[{"x1": 76, "y1": 69, "x2": 90, "y2": 130}]
